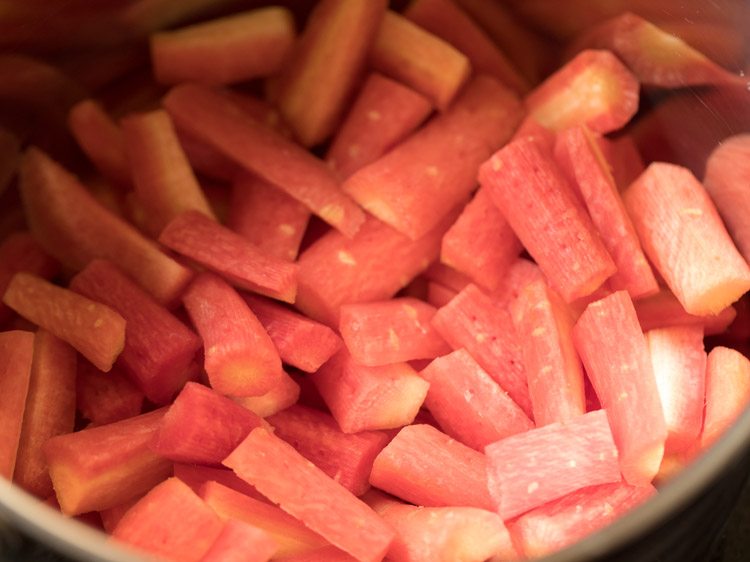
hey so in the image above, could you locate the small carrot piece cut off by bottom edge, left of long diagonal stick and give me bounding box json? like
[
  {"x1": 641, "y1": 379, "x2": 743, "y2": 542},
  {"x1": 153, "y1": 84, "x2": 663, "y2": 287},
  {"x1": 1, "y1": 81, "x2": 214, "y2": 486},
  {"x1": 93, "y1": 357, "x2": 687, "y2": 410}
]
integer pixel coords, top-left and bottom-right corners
[{"x1": 201, "y1": 519, "x2": 277, "y2": 562}]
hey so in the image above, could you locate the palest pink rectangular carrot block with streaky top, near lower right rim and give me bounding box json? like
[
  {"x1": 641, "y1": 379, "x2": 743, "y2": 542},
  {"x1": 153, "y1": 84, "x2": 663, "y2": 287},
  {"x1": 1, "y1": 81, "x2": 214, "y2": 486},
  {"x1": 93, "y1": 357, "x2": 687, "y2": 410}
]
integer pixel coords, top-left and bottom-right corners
[{"x1": 485, "y1": 410, "x2": 621, "y2": 521}]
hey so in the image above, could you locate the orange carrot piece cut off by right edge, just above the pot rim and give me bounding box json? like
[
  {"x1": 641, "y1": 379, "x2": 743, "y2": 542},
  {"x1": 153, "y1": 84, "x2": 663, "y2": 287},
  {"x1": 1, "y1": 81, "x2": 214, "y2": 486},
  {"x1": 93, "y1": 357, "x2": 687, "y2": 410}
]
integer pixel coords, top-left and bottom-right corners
[{"x1": 700, "y1": 346, "x2": 750, "y2": 449}]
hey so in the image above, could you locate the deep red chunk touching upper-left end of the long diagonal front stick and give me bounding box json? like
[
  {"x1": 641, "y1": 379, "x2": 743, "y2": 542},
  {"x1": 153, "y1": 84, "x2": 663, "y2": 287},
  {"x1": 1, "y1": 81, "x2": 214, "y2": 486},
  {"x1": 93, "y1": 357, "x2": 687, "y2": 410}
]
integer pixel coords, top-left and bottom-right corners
[{"x1": 151, "y1": 382, "x2": 263, "y2": 465}]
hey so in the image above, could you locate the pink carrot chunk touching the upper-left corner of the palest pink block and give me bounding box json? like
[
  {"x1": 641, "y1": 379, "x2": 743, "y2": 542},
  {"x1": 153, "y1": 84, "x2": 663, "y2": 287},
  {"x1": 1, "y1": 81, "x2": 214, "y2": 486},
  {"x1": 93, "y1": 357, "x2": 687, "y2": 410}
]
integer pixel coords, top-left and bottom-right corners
[{"x1": 419, "y1": 349, "x2": 534, "y2": 451}]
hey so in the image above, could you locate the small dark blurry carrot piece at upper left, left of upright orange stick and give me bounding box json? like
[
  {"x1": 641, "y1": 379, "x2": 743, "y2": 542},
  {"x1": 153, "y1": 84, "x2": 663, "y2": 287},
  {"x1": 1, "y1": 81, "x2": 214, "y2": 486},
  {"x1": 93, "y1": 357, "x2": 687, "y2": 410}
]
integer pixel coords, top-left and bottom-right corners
[{"x1": 68, "y1": 99, "x2": 131, "y2": 189}]
